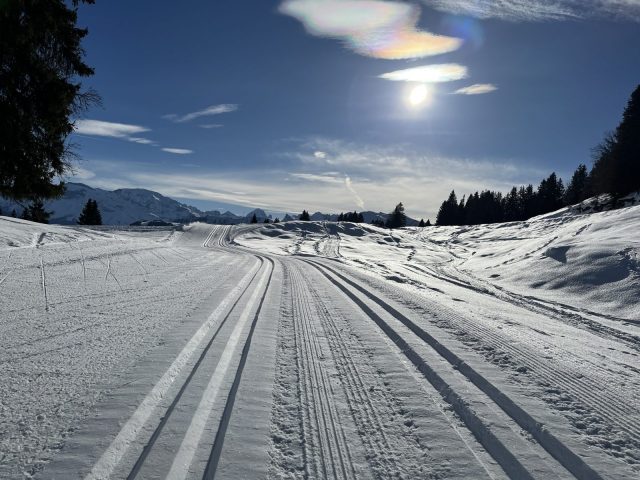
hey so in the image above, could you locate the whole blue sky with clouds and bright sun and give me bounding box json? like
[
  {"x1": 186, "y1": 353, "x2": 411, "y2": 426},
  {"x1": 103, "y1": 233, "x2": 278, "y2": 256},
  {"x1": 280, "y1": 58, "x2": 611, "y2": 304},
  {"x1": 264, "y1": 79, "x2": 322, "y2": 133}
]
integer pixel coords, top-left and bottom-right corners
[{"x1": 71, "y1": 0, "x2": 640, "y2": 220}]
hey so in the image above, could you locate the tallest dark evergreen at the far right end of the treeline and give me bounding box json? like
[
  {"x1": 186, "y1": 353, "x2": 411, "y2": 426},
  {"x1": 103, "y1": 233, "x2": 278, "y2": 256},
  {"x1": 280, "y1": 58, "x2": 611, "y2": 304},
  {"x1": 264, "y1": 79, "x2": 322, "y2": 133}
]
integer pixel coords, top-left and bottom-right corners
[{"x1": 591, "y1": 85, "x2": 640, "y2": 197}]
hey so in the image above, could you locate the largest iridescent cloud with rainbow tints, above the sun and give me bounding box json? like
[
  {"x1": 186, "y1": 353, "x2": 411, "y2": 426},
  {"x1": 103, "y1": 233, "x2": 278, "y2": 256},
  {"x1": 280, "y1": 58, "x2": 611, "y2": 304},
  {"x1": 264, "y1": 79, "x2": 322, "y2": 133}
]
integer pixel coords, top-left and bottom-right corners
[{"x1": 279, "y1": 0, "x2": 463, "y2": 60}]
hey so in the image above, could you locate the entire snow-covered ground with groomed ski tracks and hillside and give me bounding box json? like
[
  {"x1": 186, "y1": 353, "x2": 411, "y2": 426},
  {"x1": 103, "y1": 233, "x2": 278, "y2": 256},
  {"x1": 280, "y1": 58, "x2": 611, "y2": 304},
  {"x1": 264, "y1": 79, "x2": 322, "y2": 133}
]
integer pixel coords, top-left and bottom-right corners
[{"x1": 0, "y1": 206, "x2": 640, "y2": 480}]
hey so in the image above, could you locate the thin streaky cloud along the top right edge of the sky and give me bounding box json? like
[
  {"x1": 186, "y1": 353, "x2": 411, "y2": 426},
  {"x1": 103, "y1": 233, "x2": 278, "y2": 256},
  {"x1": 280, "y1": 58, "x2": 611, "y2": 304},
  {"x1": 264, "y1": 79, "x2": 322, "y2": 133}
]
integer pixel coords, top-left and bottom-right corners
[{"x1": 422, "y1": 0, "x2": 640, "y2": 21}]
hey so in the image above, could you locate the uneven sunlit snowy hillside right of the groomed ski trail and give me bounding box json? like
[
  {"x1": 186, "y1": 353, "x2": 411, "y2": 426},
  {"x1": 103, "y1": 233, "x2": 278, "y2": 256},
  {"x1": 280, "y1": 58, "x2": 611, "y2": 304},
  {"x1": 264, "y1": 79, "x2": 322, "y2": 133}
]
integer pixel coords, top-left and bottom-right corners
[{"x1": 236, "y1": 199, "x2": 640, "y2": 321}]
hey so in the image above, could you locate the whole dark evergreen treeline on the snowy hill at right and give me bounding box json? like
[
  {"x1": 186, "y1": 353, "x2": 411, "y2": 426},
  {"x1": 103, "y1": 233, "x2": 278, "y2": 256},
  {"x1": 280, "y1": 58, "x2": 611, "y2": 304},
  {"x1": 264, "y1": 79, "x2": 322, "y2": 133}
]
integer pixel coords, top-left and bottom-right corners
[{"x1": 436, "y1": 86, "x2": 640, "y2": 225}]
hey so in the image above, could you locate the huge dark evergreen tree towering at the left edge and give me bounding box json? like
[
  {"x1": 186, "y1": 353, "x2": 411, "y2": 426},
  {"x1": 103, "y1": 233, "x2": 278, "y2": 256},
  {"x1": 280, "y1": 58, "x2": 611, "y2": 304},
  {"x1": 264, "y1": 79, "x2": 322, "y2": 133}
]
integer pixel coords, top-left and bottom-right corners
[{"x1": 0, "y1": 0, "x2": 98, "y2": 205}]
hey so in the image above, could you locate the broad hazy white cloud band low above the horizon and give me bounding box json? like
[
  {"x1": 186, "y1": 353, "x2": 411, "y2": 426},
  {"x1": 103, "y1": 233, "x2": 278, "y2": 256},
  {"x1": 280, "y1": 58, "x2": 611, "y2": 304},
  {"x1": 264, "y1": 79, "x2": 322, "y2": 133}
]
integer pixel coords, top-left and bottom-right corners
[{"x1": 80, "y1": 138, "x2": 548, "y2": 221}]
